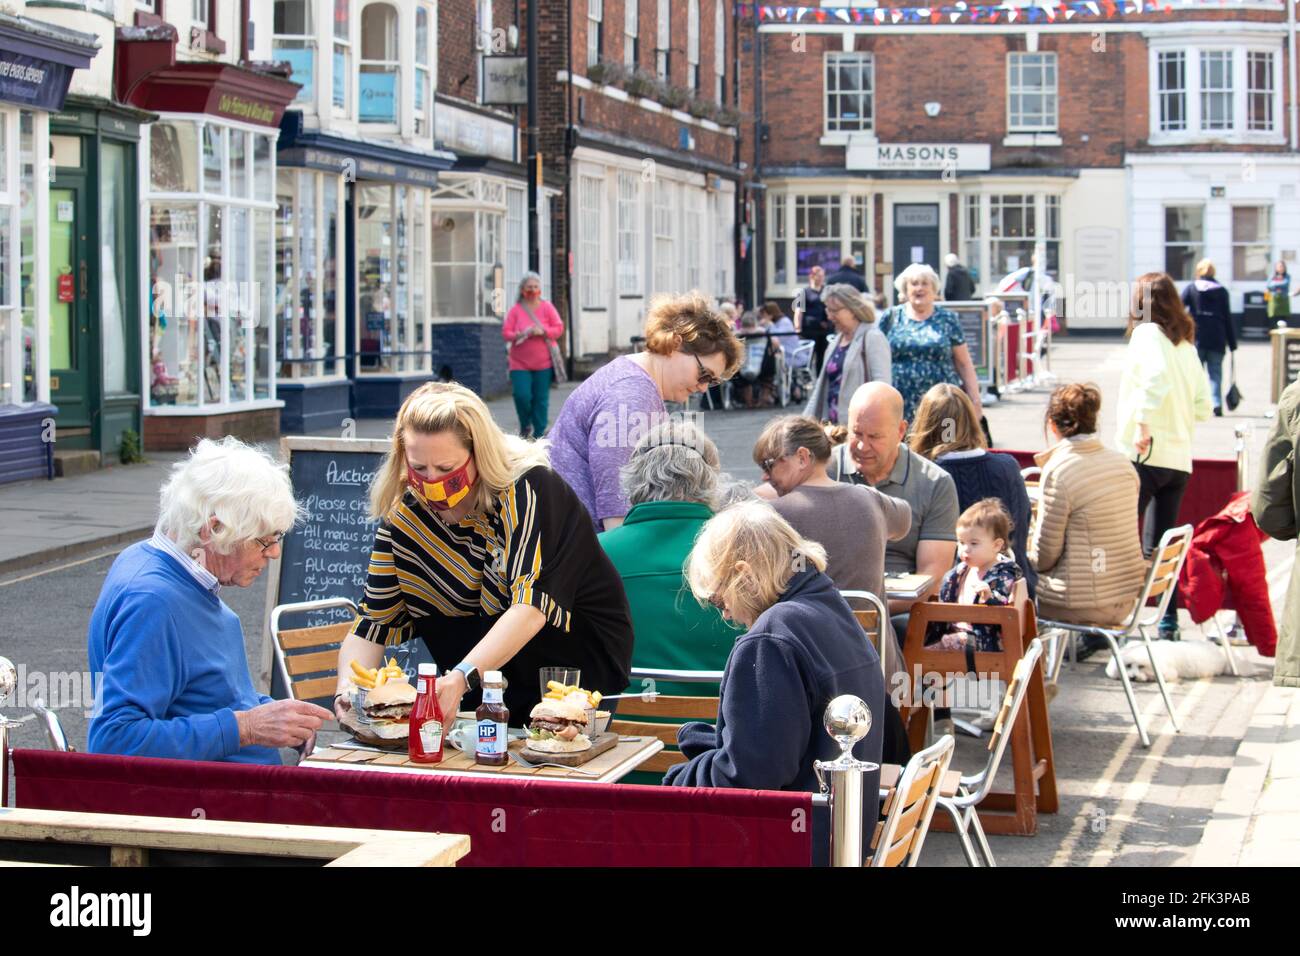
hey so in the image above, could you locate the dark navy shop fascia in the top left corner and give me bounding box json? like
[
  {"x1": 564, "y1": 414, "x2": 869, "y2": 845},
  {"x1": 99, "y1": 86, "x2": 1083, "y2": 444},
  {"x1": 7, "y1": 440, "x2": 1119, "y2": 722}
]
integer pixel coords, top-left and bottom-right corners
[{"x1": 0, "y1": 13, "x2": 99, "y2": 112}]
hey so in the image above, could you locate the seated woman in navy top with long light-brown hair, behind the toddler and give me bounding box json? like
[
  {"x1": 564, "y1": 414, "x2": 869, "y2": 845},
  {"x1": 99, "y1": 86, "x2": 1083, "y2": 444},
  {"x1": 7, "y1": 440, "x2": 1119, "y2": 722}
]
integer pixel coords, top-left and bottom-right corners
[{"x1": 907, "y1": 382, "x2": 1039, "y2": 597}]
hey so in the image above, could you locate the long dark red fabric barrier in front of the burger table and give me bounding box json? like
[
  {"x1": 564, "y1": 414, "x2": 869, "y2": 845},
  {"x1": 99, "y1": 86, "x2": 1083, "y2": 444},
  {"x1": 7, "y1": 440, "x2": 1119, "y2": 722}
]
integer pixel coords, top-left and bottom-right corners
[{"x1": 13, "y1": 750, "x2": 813, "y2": 866}]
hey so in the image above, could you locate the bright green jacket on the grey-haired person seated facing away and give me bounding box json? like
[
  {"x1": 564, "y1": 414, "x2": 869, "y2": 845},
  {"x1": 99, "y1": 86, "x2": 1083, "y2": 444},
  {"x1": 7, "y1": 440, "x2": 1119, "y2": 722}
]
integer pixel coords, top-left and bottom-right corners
[{"x1": 599, "y1": 501, "x2": 745, "y2": 697}]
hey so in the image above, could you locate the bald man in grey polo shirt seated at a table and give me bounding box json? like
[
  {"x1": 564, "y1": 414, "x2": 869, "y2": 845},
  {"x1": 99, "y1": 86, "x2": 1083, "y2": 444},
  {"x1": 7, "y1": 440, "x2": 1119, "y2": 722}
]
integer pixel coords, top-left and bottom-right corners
[{"x1": 829, "y1": 381, "x2": 961, "y2": 621}]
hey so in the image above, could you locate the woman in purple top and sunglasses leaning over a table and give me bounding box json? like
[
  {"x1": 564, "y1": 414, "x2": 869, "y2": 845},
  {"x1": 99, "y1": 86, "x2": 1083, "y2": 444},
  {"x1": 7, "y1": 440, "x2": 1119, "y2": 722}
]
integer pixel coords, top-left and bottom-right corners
[{"x1": 550, "y1": 293, "x2": 742, "y2": 531}]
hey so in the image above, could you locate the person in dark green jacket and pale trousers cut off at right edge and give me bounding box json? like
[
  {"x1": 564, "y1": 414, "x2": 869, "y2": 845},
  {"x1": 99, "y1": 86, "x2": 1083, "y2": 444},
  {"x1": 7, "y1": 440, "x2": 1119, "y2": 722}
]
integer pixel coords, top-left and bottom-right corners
[{"x1": 1251, "y1": 382, "x2": 1300, "y2": 687}]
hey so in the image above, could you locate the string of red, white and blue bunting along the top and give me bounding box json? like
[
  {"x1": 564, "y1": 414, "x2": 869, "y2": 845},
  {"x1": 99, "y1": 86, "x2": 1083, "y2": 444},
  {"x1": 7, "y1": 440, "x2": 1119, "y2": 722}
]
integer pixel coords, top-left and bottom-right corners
[{"x1": 737, "y1": 0, "x2": 1258, "y2": 26}]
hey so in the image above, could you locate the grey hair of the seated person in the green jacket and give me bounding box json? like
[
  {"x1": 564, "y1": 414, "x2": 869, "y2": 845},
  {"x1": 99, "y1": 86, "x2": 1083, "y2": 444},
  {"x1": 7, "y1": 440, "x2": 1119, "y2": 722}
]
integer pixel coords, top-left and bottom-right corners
[{"x1": 621, "y1": 419, "x2": 722, "y2": 510}]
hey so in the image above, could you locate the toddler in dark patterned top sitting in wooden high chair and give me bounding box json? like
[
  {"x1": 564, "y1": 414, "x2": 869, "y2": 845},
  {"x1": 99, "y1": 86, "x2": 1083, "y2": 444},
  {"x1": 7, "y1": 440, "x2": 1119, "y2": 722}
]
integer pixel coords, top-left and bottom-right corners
[{"x1": 926, "y1": 498, "x2": 1024, "y2": 652}]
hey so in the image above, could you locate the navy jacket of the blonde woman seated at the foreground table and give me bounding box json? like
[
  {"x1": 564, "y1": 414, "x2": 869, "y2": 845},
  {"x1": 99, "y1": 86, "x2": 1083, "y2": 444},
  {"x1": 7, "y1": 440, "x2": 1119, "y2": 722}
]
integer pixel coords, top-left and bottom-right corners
[{"x1": 664, "y1": 570, "x2": 885, "y2": 812}]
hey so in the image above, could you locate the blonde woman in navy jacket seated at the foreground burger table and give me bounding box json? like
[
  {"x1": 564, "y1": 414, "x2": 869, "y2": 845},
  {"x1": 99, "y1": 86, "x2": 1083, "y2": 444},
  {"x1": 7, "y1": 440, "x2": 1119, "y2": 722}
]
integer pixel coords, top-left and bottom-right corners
[{"x1": 664, "y1": 501, "x2": 885, "y2": 801}]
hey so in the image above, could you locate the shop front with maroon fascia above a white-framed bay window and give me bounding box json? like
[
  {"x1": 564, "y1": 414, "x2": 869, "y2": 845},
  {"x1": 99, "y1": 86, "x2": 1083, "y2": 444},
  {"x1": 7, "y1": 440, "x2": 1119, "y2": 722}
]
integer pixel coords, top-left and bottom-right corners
[{"x1": 117, "y1": 31, "x2": 298, "y2": 450}]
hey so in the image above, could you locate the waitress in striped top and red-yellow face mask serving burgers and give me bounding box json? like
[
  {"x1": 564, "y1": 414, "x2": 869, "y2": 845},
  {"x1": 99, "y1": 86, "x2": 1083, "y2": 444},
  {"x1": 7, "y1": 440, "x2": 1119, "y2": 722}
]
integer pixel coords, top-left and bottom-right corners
[{"x1": 334, "y1": 382, "x2": 632, "y2": 724}]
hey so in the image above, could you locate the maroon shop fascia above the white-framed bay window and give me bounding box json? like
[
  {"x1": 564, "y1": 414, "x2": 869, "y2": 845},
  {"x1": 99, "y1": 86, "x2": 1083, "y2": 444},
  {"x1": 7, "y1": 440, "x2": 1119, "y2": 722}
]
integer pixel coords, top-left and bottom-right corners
[{"x1": 114, "y1": 25, "x2": 298, "y2": 127}]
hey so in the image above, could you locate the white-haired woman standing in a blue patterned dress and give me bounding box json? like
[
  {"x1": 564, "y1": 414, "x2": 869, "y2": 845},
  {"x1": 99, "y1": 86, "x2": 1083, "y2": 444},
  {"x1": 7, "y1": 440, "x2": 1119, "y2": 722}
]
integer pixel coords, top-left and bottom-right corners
[{"x1": 879, "y1": 263, "x2": 984, "y2": 421}]
